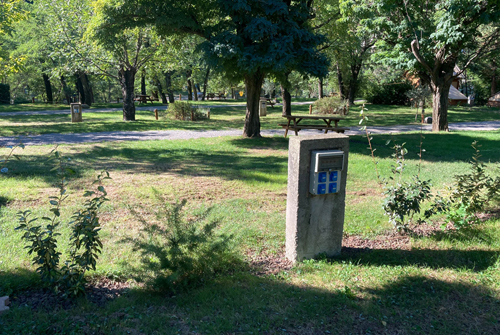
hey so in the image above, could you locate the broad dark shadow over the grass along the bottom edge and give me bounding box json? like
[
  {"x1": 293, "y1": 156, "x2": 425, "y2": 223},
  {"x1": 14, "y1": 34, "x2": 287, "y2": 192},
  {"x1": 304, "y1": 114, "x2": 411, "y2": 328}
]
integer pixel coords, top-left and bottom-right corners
[{"x1": 0, "y1": 274, "x2": 500, "y2": 334}]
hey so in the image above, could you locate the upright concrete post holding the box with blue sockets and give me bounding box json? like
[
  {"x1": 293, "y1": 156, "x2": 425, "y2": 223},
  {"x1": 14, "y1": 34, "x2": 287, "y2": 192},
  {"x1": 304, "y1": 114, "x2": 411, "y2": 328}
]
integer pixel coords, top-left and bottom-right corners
[{"x1": 286, "y1": 133, "x2": 349, "y2": 262}]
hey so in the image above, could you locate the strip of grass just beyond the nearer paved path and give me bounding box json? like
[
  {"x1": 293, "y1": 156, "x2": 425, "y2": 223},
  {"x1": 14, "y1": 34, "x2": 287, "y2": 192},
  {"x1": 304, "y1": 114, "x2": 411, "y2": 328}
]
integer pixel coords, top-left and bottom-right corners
[{"x1": 0, "y1": 100, "x2": 500, "y2": 136}]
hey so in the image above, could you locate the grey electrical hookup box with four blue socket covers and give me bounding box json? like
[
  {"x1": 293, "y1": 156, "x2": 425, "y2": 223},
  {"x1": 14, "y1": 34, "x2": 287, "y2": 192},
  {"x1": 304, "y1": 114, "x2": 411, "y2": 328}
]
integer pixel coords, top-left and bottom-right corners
[{"x1": 309, "y1": 150, "x2": 344, "y2": 195}]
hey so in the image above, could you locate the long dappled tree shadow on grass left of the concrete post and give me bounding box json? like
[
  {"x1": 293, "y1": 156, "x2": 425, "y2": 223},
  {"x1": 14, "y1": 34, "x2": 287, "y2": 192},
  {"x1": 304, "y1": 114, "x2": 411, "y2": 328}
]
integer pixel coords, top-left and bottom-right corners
[{"x1": 2, "y1": 144, "x2": 288, "y2": 186}]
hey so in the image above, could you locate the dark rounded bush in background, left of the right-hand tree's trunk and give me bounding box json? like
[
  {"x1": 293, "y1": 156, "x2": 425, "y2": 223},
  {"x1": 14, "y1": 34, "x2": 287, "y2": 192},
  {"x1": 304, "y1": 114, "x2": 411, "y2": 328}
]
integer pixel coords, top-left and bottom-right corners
[{"x1": 365, "y1": 80, "x2": 413, "y2": 105}]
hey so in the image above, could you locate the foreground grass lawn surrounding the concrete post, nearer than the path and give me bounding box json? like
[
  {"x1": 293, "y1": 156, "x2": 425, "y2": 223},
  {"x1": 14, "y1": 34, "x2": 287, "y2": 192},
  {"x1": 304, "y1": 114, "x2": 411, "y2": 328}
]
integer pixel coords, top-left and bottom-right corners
[{"x1": 0, "y1": 131, "x2": 500, "y2": 334}]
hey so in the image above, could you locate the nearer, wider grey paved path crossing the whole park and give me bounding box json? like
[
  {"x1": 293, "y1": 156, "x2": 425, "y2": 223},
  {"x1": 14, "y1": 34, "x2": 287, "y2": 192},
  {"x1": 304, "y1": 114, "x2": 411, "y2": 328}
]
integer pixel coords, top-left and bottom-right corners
[{"x1": 0, "y1": 121, "x2": 500, "y2": 145}]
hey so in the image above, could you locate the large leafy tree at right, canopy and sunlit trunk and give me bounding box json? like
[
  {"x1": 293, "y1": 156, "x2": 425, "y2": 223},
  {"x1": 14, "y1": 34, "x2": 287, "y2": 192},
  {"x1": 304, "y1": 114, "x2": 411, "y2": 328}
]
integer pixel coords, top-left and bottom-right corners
[{"x1": 343, "y1": 0, "x2": 500, "y2": 131}]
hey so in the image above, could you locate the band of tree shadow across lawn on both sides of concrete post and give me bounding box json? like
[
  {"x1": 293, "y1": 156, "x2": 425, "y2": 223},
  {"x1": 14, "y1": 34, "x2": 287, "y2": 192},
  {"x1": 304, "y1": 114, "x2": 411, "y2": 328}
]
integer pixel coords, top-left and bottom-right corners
[{"x1": 4, "y1": 133, "x2": 500, "y2": 182}]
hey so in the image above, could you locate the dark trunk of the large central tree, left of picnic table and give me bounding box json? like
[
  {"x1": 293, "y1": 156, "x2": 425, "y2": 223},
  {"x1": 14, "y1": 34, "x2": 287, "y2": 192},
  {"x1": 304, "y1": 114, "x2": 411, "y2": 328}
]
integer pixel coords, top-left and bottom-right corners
[{"x1": 243, "y1": 71, "x2": 265, "y2": 137}]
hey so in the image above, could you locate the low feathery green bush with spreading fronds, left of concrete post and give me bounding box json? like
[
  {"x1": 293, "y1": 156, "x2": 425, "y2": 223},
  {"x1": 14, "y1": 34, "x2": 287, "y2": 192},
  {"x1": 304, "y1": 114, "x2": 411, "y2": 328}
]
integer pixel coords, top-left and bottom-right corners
[{"x1": 132, "y1": 199, "x2": 236, "y2": 291}]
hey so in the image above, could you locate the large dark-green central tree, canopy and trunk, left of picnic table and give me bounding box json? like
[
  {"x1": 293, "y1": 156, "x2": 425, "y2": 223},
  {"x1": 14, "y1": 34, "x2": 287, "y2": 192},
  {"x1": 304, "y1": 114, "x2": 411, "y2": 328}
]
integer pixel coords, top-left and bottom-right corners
[{"x1": 94, "y1": 0, "x2": 326, "y2": 137}]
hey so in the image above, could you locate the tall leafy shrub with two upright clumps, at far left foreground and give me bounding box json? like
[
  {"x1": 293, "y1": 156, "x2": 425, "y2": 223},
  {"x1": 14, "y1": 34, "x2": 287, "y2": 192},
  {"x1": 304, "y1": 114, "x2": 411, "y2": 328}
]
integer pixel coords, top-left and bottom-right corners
[{"x1": 16, "y1": 151, "x2": 110, "y2": 296}]
